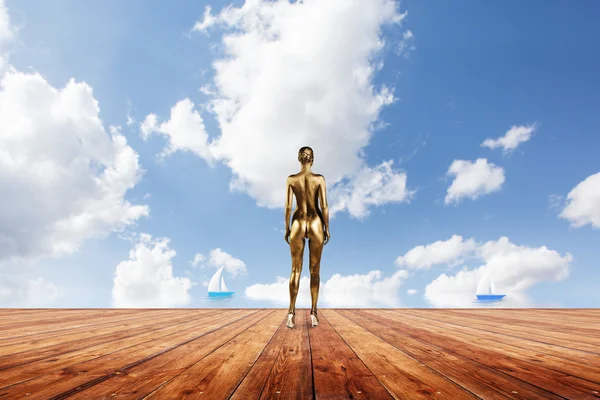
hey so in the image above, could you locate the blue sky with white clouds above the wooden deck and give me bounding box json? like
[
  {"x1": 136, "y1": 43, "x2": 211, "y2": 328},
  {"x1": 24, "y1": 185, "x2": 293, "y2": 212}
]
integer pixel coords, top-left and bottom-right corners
[{"x1": 0, "y1": 0, "x2": 600, "y2": 308}]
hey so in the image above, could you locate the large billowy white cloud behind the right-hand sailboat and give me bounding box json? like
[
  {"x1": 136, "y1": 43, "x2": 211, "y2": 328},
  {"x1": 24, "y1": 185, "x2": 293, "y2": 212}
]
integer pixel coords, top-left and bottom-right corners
[{"x1": 425, "y1": 237, "x2": 573, "y2": 307}]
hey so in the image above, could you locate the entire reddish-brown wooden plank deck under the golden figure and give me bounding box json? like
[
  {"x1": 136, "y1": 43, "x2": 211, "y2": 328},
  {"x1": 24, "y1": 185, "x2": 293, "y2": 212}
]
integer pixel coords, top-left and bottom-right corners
[{"x1": 0, "y1": 308, "x2": 600, "y2": 400}]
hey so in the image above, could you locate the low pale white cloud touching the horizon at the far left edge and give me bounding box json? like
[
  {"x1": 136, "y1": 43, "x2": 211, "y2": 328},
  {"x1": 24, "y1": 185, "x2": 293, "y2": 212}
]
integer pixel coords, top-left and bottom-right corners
[{"x1": 0, "y1": 274, "x2": 59, "y2": 307}]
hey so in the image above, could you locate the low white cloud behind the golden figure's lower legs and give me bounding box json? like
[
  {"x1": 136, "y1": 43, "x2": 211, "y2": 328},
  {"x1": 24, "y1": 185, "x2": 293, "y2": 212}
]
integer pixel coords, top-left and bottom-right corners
[{"x1": 245, "y1": 270, "x2": 409, "y2": 307}]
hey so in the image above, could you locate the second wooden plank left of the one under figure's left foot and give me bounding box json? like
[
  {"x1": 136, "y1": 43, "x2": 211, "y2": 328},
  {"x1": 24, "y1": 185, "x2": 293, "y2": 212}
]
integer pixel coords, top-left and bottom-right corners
[{"x1": 68, "y1": 310, "x2": 271, "y2": 400}]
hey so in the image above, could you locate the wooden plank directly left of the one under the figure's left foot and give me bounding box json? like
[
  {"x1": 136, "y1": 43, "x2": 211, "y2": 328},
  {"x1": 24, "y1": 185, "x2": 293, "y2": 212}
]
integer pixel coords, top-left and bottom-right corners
[{"x1": 141, "y1": 310, "x2": 286, "y2": 400}]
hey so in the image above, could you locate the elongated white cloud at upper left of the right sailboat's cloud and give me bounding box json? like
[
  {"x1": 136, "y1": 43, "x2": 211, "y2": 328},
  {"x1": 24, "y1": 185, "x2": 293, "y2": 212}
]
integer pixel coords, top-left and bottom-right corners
[{"x1": 395, "y1": 235, "x2": 477, "y2": 269}]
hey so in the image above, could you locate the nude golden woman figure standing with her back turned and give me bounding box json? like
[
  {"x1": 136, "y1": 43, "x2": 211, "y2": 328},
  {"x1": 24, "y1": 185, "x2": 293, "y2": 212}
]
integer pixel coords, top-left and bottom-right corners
[{"x1": 285, "y1": 146, "x2": 331, "y2": 328}]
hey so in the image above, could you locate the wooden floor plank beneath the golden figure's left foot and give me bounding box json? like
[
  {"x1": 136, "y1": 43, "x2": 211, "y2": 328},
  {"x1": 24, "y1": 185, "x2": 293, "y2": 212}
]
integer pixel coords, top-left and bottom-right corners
[{"x1": 230, "y1": 310, "x2": 313, "y2": 400}]
